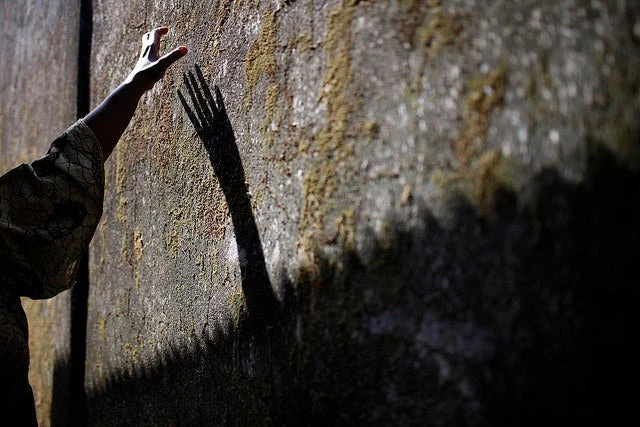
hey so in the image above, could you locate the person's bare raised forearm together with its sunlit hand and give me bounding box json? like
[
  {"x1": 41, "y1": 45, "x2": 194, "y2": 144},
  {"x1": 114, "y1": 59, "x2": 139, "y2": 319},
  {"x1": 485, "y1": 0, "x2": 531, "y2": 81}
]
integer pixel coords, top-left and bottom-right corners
[{"x1": 84, "y1": 27, "x2": 187, "y2": 160}]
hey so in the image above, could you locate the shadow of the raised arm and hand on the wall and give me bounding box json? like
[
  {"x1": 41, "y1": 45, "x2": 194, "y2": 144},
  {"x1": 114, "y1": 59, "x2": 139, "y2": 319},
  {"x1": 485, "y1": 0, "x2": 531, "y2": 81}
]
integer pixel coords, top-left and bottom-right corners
[{"x1": 178, "y1": 65, "x2": 278, "y2": 327}]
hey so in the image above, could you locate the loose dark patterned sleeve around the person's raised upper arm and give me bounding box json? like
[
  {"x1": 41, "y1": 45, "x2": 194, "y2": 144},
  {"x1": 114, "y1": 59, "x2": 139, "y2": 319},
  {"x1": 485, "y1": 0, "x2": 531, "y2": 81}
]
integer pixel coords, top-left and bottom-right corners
[{"x1": 0, "y1": 120, "x2": 104, "y2": 298}]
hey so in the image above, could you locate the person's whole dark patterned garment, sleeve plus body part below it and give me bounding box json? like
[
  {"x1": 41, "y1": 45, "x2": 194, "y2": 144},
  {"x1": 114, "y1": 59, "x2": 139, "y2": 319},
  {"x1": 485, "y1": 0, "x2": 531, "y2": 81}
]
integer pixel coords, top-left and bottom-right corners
[{"x1": 0, "y1": 120, "x2": 104, "y2": 425}]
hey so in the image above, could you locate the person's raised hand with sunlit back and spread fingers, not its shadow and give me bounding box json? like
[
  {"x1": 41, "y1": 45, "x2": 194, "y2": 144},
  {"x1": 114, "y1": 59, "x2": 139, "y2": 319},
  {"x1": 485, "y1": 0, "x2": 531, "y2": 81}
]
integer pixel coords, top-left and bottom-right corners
[{"x1": 125, "y1": 27, "x2": 188, "y2": 91}]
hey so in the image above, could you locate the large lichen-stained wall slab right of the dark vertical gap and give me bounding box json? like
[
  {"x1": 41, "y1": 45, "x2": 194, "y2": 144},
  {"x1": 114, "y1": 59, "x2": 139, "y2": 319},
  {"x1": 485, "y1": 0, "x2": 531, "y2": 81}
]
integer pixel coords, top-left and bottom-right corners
[{"x1": 87, "y1": 0, "x2": 640, "y2": 425}]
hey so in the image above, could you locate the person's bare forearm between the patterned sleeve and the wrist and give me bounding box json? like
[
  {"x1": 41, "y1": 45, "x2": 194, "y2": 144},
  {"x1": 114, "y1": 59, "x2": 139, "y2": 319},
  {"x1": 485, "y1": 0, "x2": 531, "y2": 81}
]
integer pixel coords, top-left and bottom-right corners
[{"x1": 84, "y1": 79, "x2": 145, "y2": 160}]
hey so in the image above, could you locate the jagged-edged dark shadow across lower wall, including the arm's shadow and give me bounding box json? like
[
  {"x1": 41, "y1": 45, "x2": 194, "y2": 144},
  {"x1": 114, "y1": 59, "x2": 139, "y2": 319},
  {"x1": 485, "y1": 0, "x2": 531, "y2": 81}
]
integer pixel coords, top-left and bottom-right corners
[{"x1": 81, "y1": 70, "x2": 640, "y2": 426}]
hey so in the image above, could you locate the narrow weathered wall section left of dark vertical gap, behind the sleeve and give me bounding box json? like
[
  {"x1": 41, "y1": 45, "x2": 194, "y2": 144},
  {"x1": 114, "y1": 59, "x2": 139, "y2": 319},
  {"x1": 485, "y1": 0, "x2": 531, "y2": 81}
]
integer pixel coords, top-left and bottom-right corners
[{"x1": 0, "y1": 0, "x2": 78, "y2": 425}]
